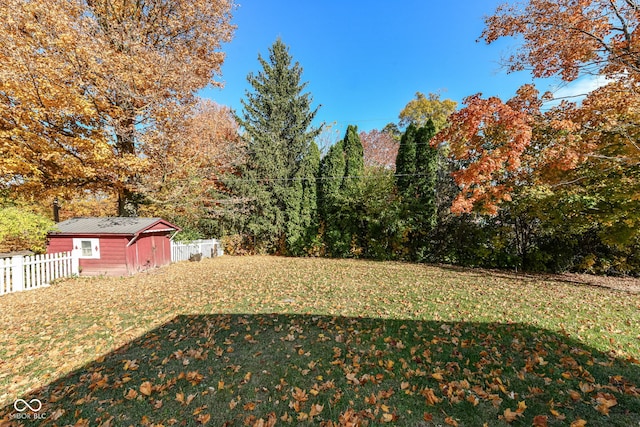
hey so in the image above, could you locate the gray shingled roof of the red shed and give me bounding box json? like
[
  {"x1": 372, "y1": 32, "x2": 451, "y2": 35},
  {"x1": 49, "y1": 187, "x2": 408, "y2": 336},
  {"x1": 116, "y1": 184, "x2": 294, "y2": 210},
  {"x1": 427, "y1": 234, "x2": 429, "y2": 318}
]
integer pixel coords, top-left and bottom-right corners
[{"x1": 53, "y1": 217, "x2": 175, "y2": 234}]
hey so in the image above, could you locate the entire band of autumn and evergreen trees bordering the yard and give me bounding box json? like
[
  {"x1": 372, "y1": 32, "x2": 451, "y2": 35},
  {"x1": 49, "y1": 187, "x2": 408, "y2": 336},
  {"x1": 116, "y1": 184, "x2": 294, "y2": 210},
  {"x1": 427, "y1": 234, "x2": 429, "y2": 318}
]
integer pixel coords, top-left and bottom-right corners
[{"x1": 0, "y1": 0, "x2": 640, "y2": 275}]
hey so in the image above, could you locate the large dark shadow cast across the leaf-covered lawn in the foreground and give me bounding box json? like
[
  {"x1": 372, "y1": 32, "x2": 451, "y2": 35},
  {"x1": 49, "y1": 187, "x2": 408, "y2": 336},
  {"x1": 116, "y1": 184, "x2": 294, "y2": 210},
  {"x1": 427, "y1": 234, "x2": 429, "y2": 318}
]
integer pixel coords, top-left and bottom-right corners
[{"x1": 0, "y1": 314, "x2": 640, "y2": 426}]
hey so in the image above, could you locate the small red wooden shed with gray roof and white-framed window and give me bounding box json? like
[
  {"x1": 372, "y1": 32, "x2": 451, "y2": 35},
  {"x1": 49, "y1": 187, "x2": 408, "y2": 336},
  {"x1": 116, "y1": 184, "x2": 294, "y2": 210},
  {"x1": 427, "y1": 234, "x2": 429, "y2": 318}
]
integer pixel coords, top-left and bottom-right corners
[{"x1": 47, "y1": 217, "x2": 180, "y2": 276}]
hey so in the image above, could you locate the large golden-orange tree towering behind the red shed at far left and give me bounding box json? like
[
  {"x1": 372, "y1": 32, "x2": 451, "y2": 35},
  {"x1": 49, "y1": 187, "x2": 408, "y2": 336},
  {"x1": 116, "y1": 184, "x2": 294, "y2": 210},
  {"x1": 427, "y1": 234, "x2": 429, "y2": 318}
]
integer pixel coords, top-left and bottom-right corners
[{"x1": 0, "y1": 0, "x2": 233, "y2": 215}]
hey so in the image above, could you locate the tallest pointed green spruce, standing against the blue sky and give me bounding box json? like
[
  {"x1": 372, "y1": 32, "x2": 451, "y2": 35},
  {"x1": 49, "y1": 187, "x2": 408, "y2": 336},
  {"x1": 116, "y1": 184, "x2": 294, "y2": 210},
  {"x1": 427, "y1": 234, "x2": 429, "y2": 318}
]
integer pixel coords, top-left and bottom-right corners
[{"x1": 237, "y1": 39, "x2": 320, "y2": 253}]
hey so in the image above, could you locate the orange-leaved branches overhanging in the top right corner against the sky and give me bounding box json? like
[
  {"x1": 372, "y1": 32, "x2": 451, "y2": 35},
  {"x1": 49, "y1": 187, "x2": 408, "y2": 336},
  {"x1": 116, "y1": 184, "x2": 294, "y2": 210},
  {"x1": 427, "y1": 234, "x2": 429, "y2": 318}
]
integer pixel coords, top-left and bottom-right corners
[{"x1": 482, "y1": 0, "x2": 640, "y2": 81}]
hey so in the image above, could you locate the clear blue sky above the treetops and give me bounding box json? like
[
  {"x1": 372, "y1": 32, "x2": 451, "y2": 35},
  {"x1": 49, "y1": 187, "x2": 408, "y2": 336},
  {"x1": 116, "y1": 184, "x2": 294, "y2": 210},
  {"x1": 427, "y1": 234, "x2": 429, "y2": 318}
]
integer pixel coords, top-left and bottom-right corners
[{"x1": 201, "y1": 0, "x2": 592, "y2": 132}]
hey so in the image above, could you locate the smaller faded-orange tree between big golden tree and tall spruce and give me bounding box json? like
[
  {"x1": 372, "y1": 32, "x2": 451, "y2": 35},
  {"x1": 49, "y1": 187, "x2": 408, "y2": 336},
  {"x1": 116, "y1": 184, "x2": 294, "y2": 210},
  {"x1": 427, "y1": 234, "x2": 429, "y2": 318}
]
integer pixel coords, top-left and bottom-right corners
[{"x1": 140, "y1": 99, "x2": 244, "y2": 234}]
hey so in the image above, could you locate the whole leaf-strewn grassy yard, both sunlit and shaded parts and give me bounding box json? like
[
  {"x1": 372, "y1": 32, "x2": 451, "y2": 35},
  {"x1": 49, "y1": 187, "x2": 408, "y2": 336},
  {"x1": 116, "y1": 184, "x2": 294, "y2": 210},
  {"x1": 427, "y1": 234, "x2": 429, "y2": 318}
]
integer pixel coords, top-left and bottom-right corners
[{"x1": 0, "y1": 257, "x2": 640, "y2": 427}]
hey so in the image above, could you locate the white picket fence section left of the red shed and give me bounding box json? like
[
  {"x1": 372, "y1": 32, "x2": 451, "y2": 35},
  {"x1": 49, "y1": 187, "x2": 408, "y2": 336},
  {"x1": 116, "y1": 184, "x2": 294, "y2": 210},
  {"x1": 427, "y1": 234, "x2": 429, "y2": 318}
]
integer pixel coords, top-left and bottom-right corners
[{"x1": 0, "y1": 252, "x2": 79, "y2": 295}]
